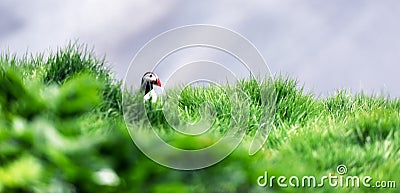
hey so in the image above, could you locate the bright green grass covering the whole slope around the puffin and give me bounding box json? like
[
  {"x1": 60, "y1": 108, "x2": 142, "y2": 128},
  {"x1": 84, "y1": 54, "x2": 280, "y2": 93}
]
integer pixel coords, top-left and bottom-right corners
[{"x1": 0, "y1": 43, "x2": 400, "y2": 193}]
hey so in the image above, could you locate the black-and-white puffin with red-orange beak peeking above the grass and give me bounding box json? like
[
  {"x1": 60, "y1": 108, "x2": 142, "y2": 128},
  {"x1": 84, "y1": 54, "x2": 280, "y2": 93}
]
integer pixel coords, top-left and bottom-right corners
[{"x1": 140, "y1": 72, "x2": 161, "y2": 103}]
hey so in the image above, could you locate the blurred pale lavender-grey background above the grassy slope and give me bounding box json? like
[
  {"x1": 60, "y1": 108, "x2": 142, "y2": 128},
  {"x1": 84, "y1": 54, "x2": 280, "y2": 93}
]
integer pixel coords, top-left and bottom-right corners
[{"x1": 0, "y1": 0, "x2": 400, "y2": 97}]
